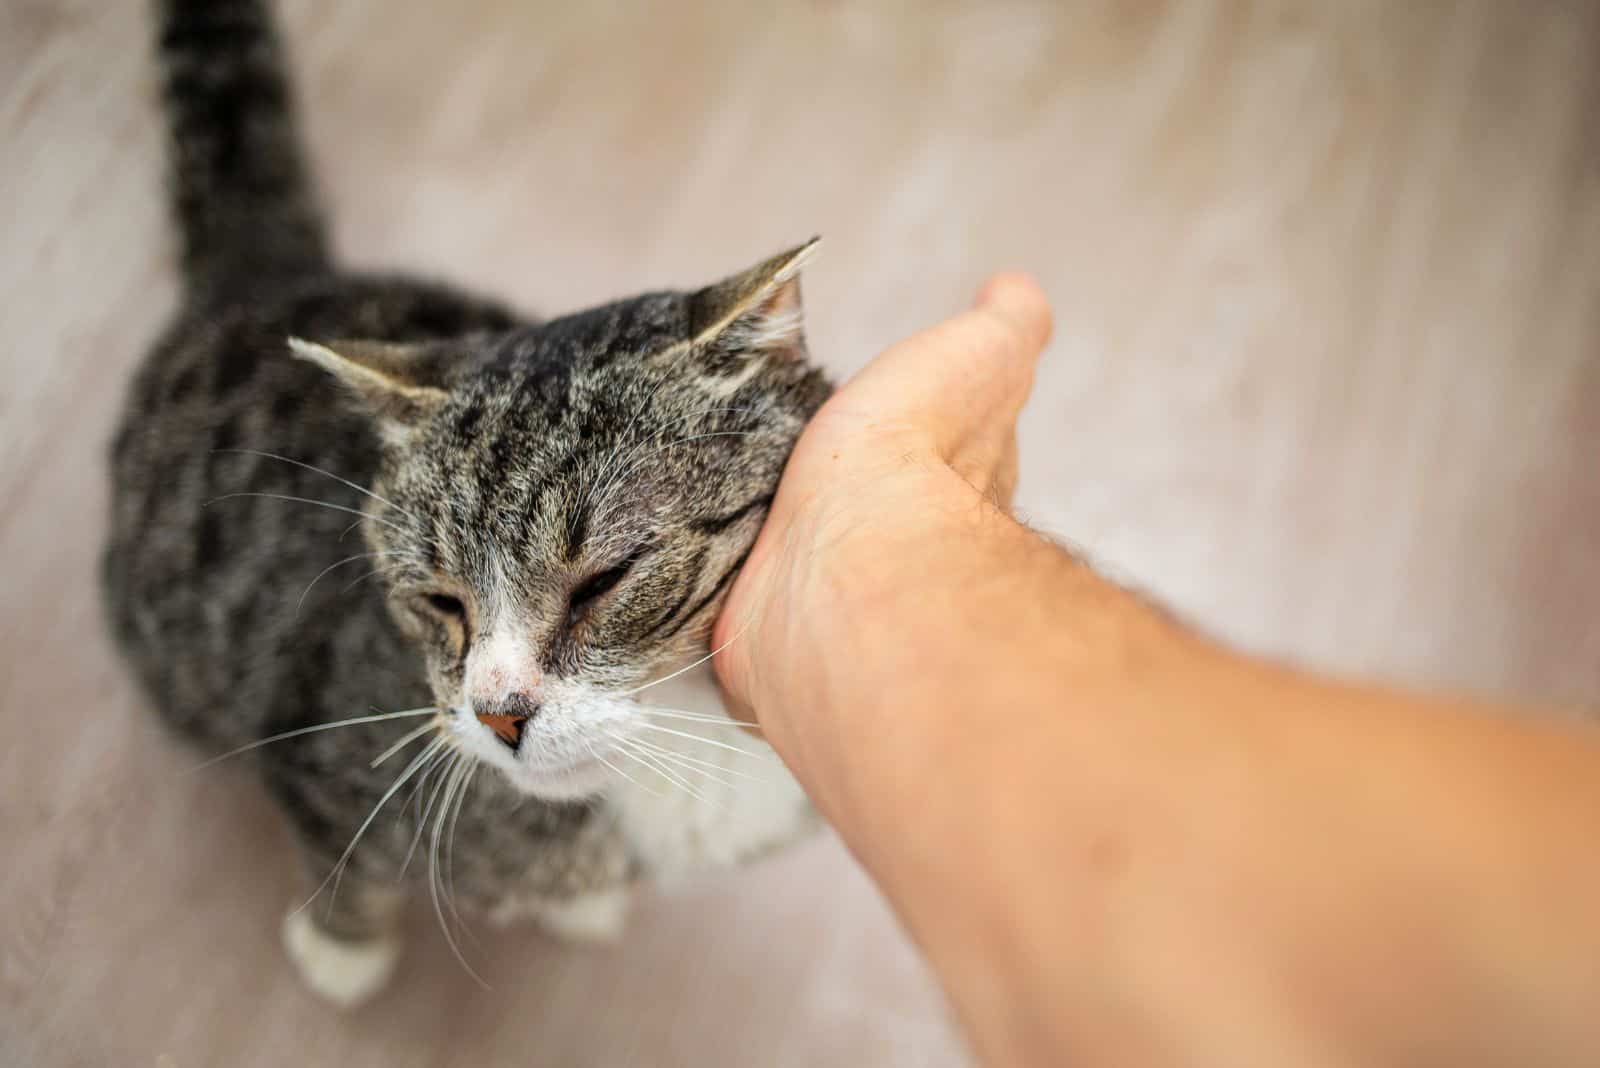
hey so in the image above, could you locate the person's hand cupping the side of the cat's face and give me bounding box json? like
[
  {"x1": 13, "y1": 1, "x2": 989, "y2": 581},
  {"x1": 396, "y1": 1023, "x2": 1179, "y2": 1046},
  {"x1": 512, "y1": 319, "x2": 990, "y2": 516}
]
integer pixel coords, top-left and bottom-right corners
[{"x1": 712, "y1": 273, "x2": 1051, "y2": 737}]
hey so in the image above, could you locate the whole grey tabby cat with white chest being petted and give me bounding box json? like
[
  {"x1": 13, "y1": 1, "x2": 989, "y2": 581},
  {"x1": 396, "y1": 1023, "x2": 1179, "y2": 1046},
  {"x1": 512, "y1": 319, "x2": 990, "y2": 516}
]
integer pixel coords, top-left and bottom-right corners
[{"x1": 104, "y1": 0, "x2": 832, "y2": 1006}]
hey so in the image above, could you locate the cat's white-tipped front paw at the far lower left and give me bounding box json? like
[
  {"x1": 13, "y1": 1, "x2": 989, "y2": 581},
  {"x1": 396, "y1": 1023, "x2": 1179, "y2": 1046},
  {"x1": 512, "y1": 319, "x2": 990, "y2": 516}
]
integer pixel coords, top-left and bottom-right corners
[{"x1": 283, "y1": 875, "x2": 405, "y2": 1009}]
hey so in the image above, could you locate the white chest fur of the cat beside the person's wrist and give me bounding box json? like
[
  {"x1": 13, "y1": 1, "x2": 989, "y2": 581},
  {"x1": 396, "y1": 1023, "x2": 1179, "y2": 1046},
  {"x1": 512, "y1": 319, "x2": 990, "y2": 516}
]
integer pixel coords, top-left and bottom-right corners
[{"x1": 606, "y1": 665, "x2": 814, "y2": 881}]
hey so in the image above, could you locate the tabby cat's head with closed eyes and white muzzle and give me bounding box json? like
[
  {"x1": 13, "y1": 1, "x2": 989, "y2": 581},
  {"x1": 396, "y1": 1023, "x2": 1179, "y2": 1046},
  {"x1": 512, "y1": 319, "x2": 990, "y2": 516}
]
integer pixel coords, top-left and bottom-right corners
[{"x1": 293, "y1": 241, "x2": 829, "y2": 799}]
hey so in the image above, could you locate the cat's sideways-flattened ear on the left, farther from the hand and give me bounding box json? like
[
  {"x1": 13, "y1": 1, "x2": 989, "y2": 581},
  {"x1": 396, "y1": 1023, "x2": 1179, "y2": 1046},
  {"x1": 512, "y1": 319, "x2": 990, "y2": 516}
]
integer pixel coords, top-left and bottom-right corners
[{"x1": 290, "y1": 337, "x2": 454, "y2": 443}]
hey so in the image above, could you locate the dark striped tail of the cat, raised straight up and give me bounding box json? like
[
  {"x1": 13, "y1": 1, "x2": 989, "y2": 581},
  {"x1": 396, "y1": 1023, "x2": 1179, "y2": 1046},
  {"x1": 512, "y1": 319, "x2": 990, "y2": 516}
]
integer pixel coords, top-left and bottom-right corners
[{"x1": 155, "y1": 0, "x2": 330, "y2": 289}]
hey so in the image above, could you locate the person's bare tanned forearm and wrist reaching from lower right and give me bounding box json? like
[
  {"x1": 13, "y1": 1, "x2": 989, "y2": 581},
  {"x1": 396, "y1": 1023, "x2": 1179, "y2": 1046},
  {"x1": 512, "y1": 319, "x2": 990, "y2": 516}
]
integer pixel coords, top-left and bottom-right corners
[{"x1": 742, "y1": 480, "x2": 1600, "y2": 1065}]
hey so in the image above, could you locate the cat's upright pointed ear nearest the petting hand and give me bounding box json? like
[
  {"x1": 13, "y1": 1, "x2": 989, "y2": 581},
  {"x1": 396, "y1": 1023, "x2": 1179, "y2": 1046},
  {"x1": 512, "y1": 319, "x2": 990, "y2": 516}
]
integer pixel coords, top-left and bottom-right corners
[{"x1": 690, "y1": 238, "x2": 821, "y2": 389}]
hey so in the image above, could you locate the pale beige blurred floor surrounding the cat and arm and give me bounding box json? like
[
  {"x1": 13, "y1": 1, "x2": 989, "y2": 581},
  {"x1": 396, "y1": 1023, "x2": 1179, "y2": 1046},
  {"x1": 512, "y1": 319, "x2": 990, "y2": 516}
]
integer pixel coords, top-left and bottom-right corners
[{"x1": 0, "y1": 0, "x2": 1600, "y2": 1068}]
